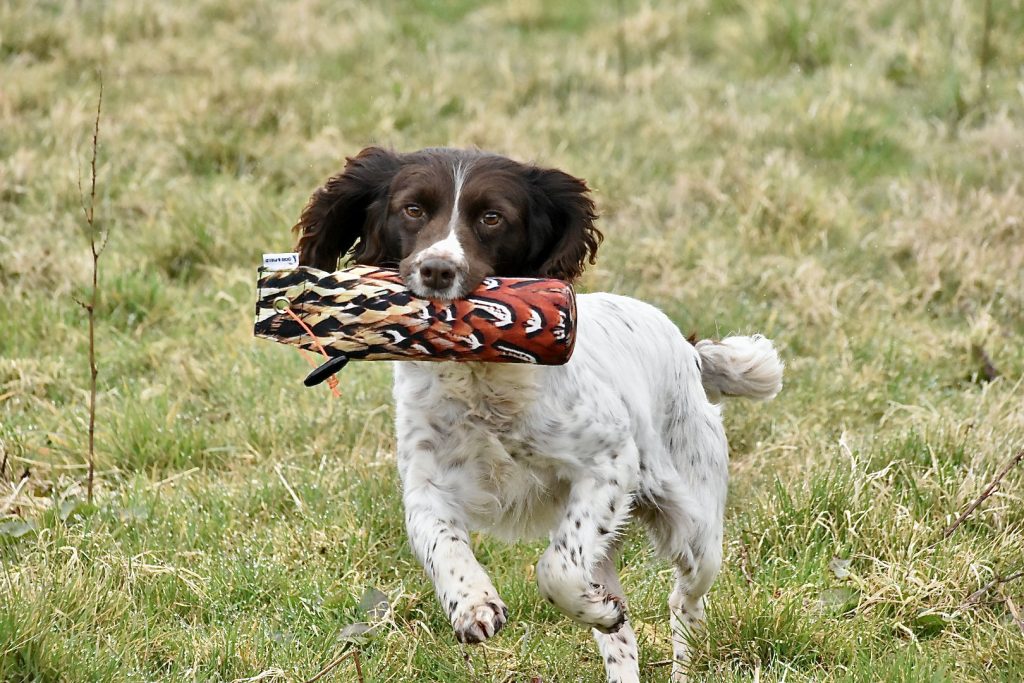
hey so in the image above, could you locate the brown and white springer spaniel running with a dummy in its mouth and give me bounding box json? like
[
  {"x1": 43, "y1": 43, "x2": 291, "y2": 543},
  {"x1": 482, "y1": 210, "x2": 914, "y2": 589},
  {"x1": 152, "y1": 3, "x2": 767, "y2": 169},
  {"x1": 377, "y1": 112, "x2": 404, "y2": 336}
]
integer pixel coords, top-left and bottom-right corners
[{"x1": 295, "y1": 147, "x2": 782, "y2": 683}]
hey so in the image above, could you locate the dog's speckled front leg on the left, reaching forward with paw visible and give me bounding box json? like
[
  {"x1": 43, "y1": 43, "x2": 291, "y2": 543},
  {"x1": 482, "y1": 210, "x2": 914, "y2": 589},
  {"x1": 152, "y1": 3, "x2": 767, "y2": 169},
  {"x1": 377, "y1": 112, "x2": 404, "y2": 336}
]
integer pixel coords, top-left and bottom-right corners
[{"x1": 403, "y1": 462, "x2": 508, "y2": 643}]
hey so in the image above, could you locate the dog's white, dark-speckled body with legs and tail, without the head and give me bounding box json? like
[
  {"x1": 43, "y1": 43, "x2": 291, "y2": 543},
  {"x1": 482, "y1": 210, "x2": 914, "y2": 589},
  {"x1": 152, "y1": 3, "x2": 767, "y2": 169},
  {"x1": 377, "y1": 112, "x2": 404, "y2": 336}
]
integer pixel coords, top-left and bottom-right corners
[{"x1": 394, "y1": 294, "x2": 781, "y2": 683}]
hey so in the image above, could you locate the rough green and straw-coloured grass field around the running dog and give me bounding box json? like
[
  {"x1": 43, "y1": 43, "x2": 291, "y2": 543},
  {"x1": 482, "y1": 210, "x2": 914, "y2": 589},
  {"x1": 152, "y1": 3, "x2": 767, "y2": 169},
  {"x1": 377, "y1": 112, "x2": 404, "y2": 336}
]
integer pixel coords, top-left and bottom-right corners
[{"x1": 0, "y1": 0, "x2": 1024, "y2": 683}]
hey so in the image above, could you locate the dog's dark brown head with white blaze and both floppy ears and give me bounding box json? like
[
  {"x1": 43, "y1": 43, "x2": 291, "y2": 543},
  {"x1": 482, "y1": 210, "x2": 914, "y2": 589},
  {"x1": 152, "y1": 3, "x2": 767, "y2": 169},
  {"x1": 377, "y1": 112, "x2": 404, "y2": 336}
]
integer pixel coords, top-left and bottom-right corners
[{"x1": 293, "y1": 147, "x2": 601, "y2": 300}]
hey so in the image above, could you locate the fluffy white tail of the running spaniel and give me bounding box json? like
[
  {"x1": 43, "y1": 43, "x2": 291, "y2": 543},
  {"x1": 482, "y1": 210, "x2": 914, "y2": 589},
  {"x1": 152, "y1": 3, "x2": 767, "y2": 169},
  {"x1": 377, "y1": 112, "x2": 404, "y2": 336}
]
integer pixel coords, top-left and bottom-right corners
[{"x1": 694, "y1": 335, "x2": 782, "y2": 403}]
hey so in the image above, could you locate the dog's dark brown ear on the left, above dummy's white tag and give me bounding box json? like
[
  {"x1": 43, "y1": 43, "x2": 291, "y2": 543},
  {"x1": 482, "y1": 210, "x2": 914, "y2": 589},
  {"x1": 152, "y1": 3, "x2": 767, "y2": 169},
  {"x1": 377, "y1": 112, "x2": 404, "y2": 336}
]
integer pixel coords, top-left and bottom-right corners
[{"x1": 292, "y1": 147, "x2": 401, "y2": 270}]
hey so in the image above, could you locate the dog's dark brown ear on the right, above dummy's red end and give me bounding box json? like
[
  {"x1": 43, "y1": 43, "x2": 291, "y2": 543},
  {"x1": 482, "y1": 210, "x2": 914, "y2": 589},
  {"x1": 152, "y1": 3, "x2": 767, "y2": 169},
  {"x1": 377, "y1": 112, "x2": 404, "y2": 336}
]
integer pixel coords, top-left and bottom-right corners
[{"x1": 526, "y1": 168, "x2": 604, "y2": 281}]
